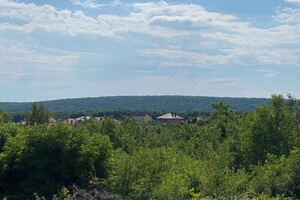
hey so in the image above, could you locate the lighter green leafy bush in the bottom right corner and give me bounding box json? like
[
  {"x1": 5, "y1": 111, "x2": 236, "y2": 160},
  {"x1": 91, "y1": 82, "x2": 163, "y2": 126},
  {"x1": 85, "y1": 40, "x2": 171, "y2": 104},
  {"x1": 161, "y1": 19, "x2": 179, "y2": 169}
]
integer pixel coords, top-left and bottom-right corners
[{"x1": 250, "y1": 148, "x2": 300, "y2": 199}]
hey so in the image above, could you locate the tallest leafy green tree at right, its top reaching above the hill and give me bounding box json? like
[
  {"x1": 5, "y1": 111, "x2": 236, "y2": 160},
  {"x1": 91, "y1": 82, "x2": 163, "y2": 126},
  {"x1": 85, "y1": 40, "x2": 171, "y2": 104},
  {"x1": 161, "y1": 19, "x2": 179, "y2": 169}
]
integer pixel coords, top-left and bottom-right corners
[{"x1": 239, "y1": 95, "x2": 299, "y2": 167}]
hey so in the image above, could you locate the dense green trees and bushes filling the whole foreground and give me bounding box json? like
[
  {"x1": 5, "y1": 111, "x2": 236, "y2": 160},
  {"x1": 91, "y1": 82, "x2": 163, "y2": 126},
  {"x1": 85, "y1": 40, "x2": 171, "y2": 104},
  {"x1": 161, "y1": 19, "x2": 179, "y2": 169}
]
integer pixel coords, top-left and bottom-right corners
[{"x1": 0, "y1": 95, "x2": 300, "y2": 200}]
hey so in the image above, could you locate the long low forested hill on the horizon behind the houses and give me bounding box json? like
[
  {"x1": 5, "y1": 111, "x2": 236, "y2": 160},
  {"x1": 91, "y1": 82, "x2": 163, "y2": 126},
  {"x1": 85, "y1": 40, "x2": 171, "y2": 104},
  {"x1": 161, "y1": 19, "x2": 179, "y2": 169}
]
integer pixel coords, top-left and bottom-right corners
[{"x1": 0, "y1": 96, "x2": 268, "y2": 113}]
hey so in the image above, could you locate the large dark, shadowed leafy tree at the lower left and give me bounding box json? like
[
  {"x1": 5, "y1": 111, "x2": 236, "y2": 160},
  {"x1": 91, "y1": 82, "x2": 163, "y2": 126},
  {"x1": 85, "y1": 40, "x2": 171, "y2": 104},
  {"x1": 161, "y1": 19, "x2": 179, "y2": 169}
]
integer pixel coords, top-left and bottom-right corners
[{"x1": 0, "y1": 124, "x2": 112, "y2": 199}]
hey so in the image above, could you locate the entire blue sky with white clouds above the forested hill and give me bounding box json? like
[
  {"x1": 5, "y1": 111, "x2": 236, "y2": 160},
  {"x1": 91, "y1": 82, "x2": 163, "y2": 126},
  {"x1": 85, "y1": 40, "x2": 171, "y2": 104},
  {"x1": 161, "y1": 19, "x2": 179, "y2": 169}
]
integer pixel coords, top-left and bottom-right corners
[{"x1": 0, "y1": 0, "x2": 300, "y2": 102}]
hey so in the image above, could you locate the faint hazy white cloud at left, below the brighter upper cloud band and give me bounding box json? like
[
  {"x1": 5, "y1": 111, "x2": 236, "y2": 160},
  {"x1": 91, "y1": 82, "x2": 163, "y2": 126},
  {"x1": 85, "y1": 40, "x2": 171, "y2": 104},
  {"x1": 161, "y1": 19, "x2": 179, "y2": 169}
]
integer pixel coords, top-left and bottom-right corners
[{"x1": 0, "y1": 39, "x2": 80, "y2": 71}]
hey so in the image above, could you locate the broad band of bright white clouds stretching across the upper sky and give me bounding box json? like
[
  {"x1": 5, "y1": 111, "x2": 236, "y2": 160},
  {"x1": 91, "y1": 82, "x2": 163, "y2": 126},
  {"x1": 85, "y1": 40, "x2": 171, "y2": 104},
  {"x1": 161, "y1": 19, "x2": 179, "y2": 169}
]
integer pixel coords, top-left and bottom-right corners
[{"x1": 0, "y1": 0, "x2": 300, "y2": 67}]
